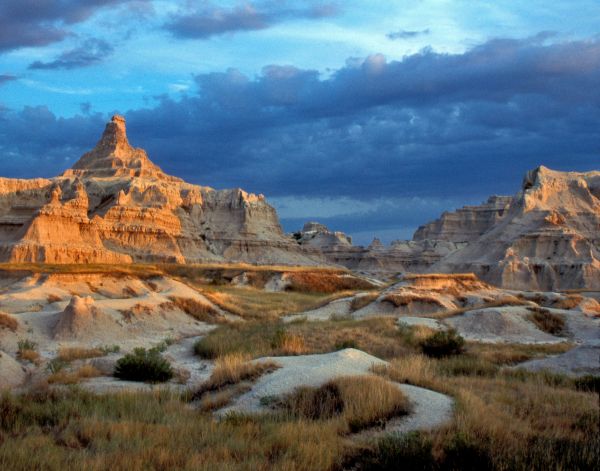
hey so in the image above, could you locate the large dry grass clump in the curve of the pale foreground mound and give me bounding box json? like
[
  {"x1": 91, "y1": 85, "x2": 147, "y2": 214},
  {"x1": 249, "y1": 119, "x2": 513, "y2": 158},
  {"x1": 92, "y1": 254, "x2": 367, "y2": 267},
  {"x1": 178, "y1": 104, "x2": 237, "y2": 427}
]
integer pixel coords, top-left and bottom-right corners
[{"x1": 278, "y1": 375, "x2": 409, "y2": 432}]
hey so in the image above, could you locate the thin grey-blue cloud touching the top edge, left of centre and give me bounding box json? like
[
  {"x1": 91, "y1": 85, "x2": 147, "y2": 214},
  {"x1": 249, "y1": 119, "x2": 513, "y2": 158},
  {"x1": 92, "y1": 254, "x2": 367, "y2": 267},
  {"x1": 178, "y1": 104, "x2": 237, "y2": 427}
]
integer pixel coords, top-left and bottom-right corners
[{"x1": 165, "y1": 0, "x2": 339, "y2": 39}]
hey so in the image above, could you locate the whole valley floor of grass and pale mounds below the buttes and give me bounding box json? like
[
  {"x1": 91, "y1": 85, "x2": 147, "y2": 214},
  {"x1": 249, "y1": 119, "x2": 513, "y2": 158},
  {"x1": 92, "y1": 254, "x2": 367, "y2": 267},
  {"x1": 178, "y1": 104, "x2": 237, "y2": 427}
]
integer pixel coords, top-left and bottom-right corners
[{"x1": 0, "y1": 265, "x2": 600, "y2": 470}]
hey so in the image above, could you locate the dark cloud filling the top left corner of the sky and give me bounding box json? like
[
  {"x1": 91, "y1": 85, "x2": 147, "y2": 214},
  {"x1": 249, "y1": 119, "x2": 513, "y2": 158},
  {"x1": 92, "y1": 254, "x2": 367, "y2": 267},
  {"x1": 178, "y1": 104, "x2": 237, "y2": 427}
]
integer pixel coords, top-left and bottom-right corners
[{"x1": 0, "y1": 0, "x2": 146, "y2": 52}]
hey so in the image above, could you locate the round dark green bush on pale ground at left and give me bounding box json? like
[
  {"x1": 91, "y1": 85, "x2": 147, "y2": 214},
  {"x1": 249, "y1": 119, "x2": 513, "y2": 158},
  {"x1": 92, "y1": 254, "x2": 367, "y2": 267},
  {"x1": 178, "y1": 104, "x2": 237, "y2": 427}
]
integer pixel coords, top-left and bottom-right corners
[{"x1": 114, "y1": 348, "x2": 174, "y2": 383}]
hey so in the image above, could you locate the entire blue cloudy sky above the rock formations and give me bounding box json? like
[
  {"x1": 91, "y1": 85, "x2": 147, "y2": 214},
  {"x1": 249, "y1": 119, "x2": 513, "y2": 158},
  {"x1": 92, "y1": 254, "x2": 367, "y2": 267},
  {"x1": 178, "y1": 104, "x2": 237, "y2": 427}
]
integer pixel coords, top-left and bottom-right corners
[{"x1": 0, "y1": 0, "x2": 600, "y2": 244}]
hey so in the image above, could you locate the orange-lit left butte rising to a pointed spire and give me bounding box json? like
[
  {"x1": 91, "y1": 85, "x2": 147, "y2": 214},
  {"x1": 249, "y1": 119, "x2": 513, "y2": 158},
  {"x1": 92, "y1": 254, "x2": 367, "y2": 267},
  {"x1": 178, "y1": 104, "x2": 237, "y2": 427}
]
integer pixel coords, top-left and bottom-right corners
[{"x1": 0, "y1": 116, "x2": 322, "y2": 265}]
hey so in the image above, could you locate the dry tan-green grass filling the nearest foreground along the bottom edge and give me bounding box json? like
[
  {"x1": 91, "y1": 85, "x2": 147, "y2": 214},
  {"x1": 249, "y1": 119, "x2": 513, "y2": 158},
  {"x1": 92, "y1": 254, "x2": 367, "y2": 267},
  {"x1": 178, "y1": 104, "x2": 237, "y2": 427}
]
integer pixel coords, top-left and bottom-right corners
[{"x1": 0, "y1": 337, "x2": 599, "y2": 470}]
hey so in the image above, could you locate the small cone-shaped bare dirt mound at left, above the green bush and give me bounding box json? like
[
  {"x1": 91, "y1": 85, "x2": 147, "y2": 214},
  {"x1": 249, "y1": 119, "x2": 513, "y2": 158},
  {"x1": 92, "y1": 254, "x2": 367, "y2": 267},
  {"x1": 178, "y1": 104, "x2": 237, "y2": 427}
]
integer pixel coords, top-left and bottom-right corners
[{"x1": 54, "y1": 296, "x2": 122, "y2": 340}]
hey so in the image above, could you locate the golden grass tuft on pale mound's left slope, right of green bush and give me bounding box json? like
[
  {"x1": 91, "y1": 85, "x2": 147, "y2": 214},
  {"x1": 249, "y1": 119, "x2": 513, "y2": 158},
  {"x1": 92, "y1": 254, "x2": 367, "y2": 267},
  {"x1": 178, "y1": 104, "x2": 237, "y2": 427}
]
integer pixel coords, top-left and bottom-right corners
[{"x1": 194, "y1": 353, "x2": 279, "y2": 398}]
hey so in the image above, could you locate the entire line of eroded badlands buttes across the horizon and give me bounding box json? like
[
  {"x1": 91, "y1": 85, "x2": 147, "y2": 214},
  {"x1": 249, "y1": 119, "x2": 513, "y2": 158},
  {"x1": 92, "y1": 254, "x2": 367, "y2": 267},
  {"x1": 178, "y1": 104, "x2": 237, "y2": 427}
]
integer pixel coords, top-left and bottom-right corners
[{"x1": 0, "y1": 116, "x2": 600, "y2": 290}]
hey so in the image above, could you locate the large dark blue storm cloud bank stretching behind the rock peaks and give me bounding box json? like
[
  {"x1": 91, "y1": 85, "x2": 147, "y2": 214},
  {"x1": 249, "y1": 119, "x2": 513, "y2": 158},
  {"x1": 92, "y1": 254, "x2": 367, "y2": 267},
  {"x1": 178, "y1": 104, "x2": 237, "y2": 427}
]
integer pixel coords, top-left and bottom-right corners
[{"x1": 0, "y1": 36, "x2": 600, "y2": 240}]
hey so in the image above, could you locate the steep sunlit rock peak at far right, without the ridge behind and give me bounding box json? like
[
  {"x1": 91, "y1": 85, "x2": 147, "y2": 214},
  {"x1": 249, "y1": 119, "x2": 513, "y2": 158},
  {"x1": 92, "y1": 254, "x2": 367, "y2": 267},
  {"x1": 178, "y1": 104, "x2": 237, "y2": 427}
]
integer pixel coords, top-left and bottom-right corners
[{"x1": 433, "y1": 167, "x2": 600, "y2": 290}]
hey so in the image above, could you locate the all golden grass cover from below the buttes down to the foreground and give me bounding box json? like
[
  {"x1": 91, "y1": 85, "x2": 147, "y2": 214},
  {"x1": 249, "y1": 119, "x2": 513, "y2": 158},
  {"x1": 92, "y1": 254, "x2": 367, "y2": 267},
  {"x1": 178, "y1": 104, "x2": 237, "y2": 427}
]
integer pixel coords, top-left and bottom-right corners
[{"x1": 0, "y1": 265, "x2": 600, "y2": 471}]
